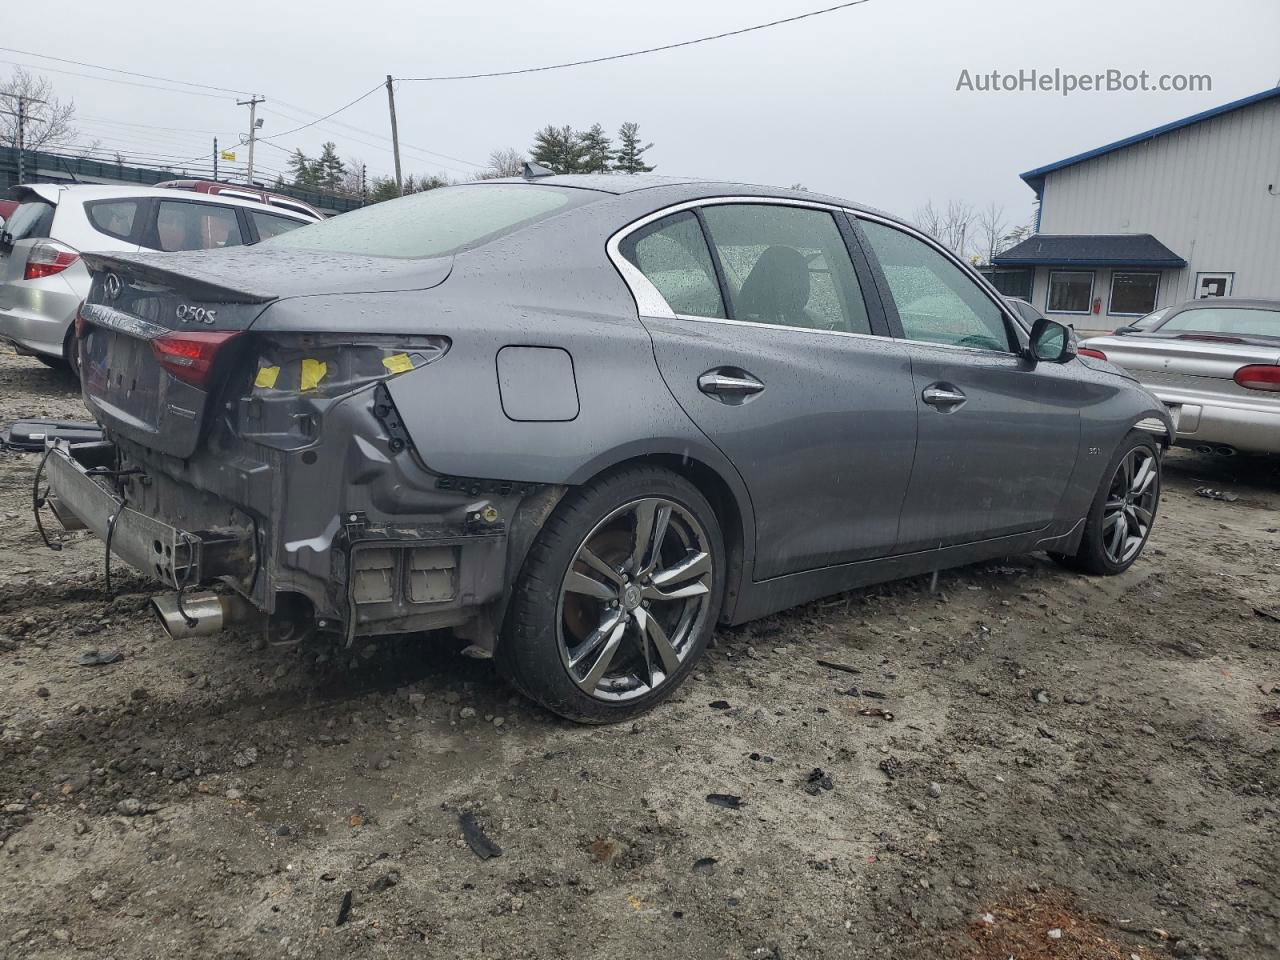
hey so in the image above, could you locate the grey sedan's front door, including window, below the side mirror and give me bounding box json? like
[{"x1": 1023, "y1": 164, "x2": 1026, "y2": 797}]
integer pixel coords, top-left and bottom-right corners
[{"x1": 858, "y1": 216, "x2": 1091, "y2": 553}]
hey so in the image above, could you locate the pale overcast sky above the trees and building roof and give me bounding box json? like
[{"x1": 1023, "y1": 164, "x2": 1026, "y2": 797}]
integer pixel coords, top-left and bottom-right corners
[{"x1": 10, "y1": 0, "x2": 1280, "y2": 221}]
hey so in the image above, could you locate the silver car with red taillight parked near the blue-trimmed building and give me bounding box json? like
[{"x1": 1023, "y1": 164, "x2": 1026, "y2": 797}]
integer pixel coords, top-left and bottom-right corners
[{"x1": 1080, "y1": 297, "x2": 1280, "y2": 456}]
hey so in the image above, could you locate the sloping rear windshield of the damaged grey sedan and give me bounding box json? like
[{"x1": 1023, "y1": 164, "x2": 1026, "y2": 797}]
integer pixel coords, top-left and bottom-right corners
[{"x1": 267, "y1": 183, "x2": 600, "y2": 257}]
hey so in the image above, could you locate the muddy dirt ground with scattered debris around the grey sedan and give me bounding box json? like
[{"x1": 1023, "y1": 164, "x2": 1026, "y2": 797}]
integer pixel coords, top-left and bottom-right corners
[{"x1": 0, "y1": 352, "x2": 1280, "y2": 960}]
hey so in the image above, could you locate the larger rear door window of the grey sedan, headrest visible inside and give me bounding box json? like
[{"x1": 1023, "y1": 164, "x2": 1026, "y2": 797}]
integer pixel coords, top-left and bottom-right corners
[{"x1": 703, "y1": 204, "x2": 872, "y2": 333}]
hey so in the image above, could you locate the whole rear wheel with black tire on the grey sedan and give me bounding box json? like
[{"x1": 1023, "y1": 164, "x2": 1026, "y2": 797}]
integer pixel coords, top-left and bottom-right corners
[{"x1": 497, "y1": 466, "x2": 724, "y2": 723}]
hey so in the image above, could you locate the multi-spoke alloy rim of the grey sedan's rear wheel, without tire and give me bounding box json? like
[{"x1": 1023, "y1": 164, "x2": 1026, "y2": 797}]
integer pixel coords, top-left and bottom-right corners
[{"x1": 557, "y1": 497, "x2": 714, "y2": 701}]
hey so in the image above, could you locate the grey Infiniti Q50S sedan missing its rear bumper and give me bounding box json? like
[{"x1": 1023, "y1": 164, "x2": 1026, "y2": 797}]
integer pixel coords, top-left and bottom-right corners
[{"x1": 46, "y1": 175, "x2": 1172, "y2": 722}]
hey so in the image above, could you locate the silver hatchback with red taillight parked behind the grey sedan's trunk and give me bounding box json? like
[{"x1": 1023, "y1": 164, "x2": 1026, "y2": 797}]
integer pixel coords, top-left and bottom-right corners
[{"x1": 0, "y1": 184, "x2": 319, "y2": 376}]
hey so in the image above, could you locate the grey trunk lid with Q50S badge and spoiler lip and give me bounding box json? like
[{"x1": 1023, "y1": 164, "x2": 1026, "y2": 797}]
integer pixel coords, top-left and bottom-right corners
[{"x1": 81, "y1": 250, "x2": 452, "y2": 458}]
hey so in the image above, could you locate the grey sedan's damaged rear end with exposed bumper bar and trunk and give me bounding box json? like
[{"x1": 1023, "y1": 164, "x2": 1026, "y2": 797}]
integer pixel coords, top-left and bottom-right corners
[{"x1": 44, "y1": 245, "x2": 558, "y2": 649}]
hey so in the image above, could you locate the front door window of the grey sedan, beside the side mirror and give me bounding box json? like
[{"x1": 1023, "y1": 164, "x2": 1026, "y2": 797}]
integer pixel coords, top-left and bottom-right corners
[{"x1": 861, "y1": 220, "x2": 1012, "y2": 352}]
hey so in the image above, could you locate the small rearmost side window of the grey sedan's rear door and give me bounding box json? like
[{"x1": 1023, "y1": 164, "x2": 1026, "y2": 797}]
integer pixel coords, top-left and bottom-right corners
[{"x1": 620, "y1": 212, "x2": 724, "y2": 319}]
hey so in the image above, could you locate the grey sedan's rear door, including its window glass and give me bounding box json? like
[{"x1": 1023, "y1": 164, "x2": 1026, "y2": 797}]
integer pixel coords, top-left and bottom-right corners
[{"x1": 618, "y1": 200, "x2": 915, "y2": 580}]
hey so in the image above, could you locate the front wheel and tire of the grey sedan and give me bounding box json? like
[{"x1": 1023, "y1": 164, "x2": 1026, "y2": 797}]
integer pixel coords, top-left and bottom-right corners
[{"x1": 1050, "y1": 430, "x2": 1161, "y2": 576}]
